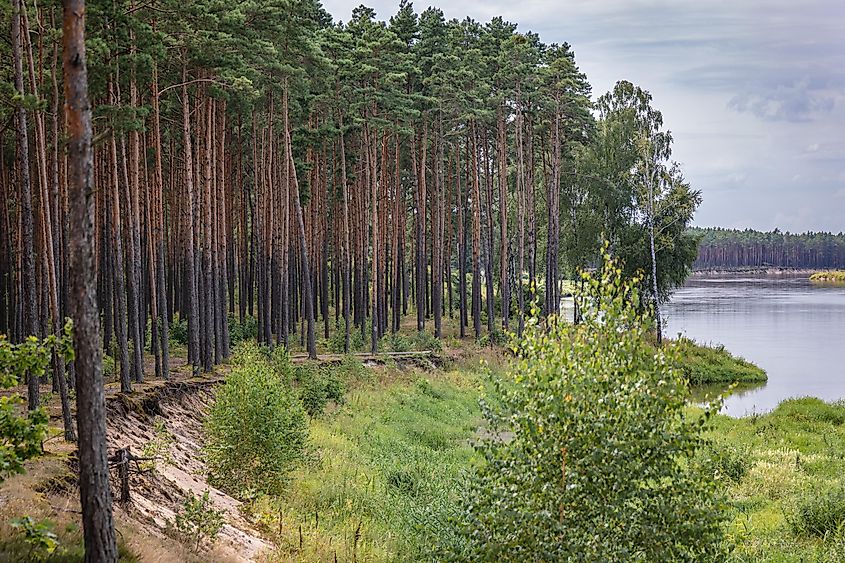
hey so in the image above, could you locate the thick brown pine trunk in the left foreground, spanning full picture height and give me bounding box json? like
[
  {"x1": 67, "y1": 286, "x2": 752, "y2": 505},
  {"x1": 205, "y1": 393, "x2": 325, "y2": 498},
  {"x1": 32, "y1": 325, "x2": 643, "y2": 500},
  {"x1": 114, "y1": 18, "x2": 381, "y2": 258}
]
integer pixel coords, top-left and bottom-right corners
[{"x1": 63, "y1": 0, "x2": 117, "y2": 563}]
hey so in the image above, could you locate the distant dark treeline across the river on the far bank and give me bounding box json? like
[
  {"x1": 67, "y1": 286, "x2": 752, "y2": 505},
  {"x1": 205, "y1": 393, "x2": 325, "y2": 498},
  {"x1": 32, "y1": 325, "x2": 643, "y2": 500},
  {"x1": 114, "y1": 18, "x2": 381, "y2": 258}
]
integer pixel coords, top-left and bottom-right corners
[{"x1": 689, "y1": 227, "x2": 845, "y2": 270}]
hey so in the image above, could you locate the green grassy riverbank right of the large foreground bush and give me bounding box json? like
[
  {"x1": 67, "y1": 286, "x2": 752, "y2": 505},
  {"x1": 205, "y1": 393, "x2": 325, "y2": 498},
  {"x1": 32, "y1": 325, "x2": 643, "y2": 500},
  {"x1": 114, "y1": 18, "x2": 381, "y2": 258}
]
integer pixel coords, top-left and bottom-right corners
[{"x1": 711, "y1": 398, "x2": 845, "y2": 562}]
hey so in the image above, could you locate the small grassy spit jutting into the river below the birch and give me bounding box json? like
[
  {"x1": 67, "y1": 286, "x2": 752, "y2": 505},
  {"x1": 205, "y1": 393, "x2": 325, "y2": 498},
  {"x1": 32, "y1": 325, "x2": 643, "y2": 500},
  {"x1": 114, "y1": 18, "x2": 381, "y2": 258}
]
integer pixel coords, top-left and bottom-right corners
[{"x1": 671, "y1": 338, "x2": 767, "y2": 385}]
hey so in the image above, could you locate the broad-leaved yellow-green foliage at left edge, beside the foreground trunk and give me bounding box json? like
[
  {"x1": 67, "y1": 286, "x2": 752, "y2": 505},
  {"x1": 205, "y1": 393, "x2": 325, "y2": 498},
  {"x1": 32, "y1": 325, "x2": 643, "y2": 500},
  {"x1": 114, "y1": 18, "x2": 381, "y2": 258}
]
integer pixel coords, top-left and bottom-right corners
[{"x1": 0, "y1": 319, "x2": 73, "y2": 479}]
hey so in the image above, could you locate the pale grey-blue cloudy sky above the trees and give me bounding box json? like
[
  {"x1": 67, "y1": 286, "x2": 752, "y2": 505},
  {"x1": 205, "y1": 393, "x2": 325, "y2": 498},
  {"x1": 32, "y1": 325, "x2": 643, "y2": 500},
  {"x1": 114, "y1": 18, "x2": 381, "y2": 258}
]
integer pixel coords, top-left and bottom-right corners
[{"x1": 323, "y1": 0, "x2": 845, "y2": 232}]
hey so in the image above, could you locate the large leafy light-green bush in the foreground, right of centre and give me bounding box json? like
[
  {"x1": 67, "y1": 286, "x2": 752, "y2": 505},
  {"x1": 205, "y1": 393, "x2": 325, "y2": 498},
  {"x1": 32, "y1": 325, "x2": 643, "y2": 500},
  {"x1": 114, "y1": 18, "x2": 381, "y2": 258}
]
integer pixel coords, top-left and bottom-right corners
[{"x1": 447, "y1": 255, "x2": 726, "y2": 561}]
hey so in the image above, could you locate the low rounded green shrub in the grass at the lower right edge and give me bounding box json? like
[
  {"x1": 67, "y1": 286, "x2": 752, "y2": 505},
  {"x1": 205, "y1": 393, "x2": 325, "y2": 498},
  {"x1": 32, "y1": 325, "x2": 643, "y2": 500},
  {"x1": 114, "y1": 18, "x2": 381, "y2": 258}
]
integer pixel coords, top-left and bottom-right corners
[{"x1": 786, "y1": 484, "x2": 845, "y2": 537}]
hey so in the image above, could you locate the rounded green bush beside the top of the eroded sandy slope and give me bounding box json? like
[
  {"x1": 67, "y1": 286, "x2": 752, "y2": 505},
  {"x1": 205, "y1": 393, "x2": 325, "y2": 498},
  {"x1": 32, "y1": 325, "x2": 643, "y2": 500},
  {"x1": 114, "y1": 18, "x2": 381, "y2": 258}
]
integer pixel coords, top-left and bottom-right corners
[{"x1": 205, "y1": 343, "x2": 308, "y2": 497}]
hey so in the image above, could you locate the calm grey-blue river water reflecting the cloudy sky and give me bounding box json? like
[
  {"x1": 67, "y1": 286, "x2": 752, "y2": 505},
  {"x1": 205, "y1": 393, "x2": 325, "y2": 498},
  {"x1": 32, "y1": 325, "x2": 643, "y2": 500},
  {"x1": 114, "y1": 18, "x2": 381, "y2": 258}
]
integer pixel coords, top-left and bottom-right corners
[{"x1": 664, "y1": 275, "x2": 845, "y2": 416}]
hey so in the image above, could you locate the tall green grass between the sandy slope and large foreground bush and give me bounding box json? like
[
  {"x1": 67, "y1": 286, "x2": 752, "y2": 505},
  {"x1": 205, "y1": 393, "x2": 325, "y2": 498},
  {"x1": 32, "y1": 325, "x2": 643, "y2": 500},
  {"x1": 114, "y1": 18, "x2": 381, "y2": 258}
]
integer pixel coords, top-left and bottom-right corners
[{"x1": 251, "y1": 352, "x2": 492, "y2": 561}]
